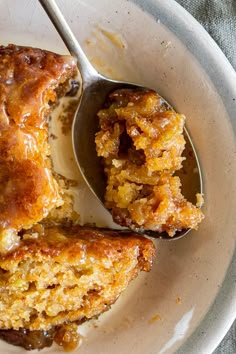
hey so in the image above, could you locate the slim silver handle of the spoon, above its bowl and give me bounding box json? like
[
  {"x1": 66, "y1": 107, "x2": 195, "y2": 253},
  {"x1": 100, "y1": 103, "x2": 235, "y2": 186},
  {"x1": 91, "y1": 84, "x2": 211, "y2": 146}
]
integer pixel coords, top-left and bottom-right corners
[{"x1": 39, "y1": 0, "x2": 98, "y2": 83}]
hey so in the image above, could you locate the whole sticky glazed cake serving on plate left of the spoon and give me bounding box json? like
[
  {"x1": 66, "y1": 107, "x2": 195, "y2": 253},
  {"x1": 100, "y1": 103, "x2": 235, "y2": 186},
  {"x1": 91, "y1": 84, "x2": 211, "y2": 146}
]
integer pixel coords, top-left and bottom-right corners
[{"x1": 0, "y1": 45, "x2": 155, "y2": 350}]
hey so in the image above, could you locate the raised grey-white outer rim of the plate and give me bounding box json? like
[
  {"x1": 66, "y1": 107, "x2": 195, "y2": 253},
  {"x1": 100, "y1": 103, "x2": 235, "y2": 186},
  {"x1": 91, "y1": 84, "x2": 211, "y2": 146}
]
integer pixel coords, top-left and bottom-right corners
[{"x1": 132, "y1": 0, "x2": 236, "y2": 354}]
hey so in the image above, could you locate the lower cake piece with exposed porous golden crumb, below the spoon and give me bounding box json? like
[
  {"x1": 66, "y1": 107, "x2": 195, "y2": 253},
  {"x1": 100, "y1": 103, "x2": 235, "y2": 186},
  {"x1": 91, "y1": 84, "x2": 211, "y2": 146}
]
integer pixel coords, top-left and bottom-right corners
[{"x1": 0, "y1": 226, "x2": 155, "y2": 330}]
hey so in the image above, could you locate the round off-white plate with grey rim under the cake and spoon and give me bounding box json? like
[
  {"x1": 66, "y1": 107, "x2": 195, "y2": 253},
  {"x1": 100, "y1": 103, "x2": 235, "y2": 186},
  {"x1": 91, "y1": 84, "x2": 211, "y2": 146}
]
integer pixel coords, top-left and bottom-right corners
[{"x1": 0, "y1": 0, "x2": 236, "y2": 354}]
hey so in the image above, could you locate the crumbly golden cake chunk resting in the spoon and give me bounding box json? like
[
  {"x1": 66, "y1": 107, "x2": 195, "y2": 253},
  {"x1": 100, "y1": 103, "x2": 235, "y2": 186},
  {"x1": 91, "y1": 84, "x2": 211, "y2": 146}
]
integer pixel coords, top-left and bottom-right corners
[{"x1": 95, "y1": 89, "x2": 204, "y2": 237}]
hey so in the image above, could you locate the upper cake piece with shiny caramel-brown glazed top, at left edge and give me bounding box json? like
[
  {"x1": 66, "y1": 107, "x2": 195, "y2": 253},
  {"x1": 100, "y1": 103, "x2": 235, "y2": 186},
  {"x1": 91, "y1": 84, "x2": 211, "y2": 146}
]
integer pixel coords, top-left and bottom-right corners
[{"x1": 0, "y1": 45, "x2": 77, "y2": 253}]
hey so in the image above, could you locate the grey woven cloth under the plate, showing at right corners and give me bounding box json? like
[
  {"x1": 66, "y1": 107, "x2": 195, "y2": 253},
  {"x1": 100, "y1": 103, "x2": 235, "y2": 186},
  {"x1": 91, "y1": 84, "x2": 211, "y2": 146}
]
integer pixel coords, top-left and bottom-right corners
[{"x1": 176, "y1": 0, "x2": 236, "y2": 354}]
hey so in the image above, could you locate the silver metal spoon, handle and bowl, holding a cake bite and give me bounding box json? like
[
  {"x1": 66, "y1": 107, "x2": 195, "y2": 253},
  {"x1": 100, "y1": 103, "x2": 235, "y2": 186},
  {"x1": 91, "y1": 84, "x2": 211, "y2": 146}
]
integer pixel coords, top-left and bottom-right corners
[{"x1": 39, "y1": 0, "x2": 202, "y2": 240}]
